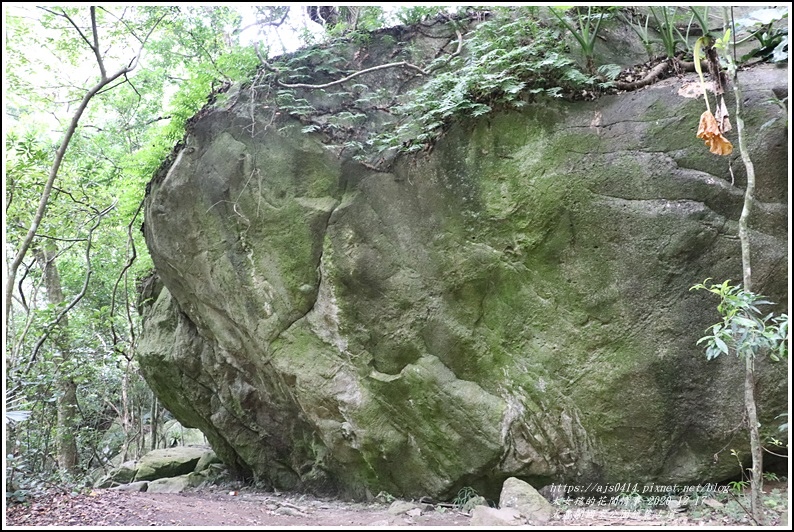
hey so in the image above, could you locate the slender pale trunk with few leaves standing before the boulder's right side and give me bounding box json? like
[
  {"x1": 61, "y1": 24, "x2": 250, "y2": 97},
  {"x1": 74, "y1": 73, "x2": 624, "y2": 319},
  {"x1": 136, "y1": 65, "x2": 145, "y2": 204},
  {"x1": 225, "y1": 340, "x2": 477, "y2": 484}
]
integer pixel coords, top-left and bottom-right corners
[{"x1": 733, "y1": 70, "x2": 764, "y2": 525}]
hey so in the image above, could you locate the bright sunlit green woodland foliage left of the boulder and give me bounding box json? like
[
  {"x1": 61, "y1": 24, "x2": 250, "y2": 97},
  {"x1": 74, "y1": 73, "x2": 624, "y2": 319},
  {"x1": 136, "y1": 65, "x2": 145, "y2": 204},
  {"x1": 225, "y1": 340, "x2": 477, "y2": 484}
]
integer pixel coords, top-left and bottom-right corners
[{"x1": 5, "y1": 6, "x2": 258, "y2": 496}]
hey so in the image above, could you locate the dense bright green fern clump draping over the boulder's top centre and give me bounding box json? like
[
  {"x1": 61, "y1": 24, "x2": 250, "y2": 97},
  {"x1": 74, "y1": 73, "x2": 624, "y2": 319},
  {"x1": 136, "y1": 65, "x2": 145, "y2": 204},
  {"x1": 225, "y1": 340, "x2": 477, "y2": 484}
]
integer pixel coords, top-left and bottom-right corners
[{"x1": 370, "y1": 8, "x2": 597, "y2": 153}]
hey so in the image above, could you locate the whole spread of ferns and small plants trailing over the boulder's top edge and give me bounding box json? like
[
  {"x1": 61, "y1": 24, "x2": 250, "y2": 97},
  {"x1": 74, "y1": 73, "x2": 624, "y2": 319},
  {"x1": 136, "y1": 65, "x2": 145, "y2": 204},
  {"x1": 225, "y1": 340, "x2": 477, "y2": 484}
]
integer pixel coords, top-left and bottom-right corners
[{"x1": 259, "y1": 7, "x2": 604, "y2": 161}]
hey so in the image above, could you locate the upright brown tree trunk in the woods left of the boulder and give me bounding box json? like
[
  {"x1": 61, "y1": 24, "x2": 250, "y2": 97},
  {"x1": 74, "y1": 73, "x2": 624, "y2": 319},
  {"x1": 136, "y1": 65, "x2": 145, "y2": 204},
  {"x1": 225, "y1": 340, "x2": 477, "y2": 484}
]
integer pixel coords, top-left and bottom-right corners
[{"x1": 35, "y1": 244, "x2": 78, "y2": 473}]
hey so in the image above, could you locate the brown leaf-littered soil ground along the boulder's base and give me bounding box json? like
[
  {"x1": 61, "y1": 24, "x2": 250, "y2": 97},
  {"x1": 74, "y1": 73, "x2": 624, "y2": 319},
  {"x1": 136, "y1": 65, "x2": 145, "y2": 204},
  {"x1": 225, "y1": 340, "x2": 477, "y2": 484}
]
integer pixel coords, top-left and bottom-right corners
[{"x1": 3, "y1": 483, "x2": 790, "y2": 529}]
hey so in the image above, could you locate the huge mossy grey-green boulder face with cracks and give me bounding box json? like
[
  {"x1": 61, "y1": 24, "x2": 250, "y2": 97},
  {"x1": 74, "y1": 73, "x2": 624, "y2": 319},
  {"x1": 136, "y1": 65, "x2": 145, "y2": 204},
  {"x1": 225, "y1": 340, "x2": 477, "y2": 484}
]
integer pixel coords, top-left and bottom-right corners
[{"x1": 139, "y1": 33, "x2": 788, "y2": 497}]
